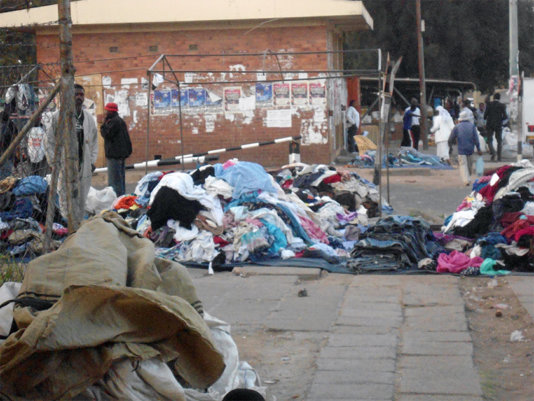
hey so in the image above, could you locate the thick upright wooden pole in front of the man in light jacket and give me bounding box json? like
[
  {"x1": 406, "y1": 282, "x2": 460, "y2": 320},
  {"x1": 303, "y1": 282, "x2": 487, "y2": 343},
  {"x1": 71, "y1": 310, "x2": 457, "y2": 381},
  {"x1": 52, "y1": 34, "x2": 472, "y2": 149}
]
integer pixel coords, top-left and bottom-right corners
[{"x1": 56, "y1": 0, "x2": 81, "y2": 233}]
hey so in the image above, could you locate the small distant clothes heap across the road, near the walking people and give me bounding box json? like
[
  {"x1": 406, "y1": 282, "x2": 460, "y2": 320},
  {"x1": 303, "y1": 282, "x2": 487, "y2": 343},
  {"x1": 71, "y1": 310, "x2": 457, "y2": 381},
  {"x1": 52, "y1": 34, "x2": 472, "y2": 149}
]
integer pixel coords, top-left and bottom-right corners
[{"x1": 350, "y1": 147, "x2": 452, "y2": 170}]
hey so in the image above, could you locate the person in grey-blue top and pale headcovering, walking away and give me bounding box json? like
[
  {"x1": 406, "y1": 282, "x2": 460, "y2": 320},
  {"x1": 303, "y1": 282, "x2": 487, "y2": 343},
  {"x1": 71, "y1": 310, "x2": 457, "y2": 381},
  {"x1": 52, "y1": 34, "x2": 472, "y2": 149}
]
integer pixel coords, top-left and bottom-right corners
[{"x1": 449, "y1": 110, "x2": 482, "y2": 186}]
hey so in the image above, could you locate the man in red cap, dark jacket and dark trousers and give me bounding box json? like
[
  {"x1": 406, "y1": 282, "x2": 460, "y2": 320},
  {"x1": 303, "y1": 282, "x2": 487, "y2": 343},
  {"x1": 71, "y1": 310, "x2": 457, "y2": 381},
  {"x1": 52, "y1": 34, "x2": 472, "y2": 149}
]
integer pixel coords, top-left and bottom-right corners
[{"x1": 100, "y1": 103, "x2": 132, "y2": 196}]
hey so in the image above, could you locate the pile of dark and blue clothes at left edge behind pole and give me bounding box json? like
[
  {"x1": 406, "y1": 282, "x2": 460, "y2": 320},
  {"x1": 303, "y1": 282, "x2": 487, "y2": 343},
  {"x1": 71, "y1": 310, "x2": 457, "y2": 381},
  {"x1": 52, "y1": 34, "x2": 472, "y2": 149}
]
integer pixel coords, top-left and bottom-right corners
[{"x1": 0, "y1": 175, "x2": 67, "y2": 259}]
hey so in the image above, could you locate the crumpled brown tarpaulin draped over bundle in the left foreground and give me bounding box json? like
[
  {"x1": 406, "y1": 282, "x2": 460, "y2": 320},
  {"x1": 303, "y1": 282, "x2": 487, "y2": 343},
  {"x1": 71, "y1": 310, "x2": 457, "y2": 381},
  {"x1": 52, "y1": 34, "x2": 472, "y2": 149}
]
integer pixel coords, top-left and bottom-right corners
[{"x1": 0, "y1": 212, "x2": 224, "y2": 400}]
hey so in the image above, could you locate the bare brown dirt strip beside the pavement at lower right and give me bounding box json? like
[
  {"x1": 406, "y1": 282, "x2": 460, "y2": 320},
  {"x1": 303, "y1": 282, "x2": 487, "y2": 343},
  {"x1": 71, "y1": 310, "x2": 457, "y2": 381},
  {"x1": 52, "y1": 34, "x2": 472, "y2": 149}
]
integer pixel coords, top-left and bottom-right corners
[{"x1": 460, "y1": 277, "x2": 534, "y2": 401}]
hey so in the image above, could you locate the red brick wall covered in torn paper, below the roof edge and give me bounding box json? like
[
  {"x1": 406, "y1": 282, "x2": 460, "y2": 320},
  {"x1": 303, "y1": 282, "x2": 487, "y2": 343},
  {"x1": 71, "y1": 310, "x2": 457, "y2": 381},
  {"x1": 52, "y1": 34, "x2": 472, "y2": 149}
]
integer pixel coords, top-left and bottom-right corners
[{"x1": 37, "y1": 26, "x2": 340, "y2": 167}]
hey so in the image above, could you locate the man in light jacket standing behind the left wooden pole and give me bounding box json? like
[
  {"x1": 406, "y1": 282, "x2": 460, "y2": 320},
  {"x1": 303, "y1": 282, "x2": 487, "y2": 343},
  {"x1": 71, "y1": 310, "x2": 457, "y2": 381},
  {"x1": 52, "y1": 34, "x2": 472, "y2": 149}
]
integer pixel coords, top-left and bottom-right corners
[{"x1": 46, "y1": 84, "x2": 98, "y2": 220}]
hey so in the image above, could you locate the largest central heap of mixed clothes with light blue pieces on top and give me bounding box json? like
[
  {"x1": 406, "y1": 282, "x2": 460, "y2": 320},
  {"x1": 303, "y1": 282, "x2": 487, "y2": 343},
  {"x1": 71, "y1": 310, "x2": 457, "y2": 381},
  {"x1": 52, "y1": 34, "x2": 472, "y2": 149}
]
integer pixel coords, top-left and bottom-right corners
[{"x1": 113, "y1": 159, "x2": 390, "y2": 267}]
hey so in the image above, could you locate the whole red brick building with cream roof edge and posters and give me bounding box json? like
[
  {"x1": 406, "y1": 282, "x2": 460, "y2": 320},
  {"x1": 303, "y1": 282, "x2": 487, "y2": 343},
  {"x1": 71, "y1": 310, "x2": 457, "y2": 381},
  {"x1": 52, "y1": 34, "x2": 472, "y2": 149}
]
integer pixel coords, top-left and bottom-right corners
[{"x1": 0, "y1": 0, "x2": 372, "y2": 167}]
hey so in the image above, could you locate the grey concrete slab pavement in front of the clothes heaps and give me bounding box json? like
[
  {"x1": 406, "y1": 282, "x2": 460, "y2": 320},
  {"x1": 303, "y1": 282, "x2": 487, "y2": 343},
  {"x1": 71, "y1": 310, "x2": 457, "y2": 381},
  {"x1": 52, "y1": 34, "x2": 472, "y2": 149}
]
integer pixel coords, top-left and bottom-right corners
[{"x1": 190, "y1": 267, "x2": 534, "y2": 401}]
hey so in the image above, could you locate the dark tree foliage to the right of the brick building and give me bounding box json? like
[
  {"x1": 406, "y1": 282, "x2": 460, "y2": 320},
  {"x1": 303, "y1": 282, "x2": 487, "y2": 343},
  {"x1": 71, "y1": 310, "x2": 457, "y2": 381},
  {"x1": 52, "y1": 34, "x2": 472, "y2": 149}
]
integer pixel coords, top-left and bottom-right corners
[{"x1": 345, "y1": 0, "x2": 534, "y2": 91}]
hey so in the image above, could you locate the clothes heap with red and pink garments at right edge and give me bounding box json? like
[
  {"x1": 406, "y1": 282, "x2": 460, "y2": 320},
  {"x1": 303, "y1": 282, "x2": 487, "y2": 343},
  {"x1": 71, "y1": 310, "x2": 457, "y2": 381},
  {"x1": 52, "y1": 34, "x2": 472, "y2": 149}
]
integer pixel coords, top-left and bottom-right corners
[{"x1": 437, "y1": 160, "x2": 534, "y2": 274}]
